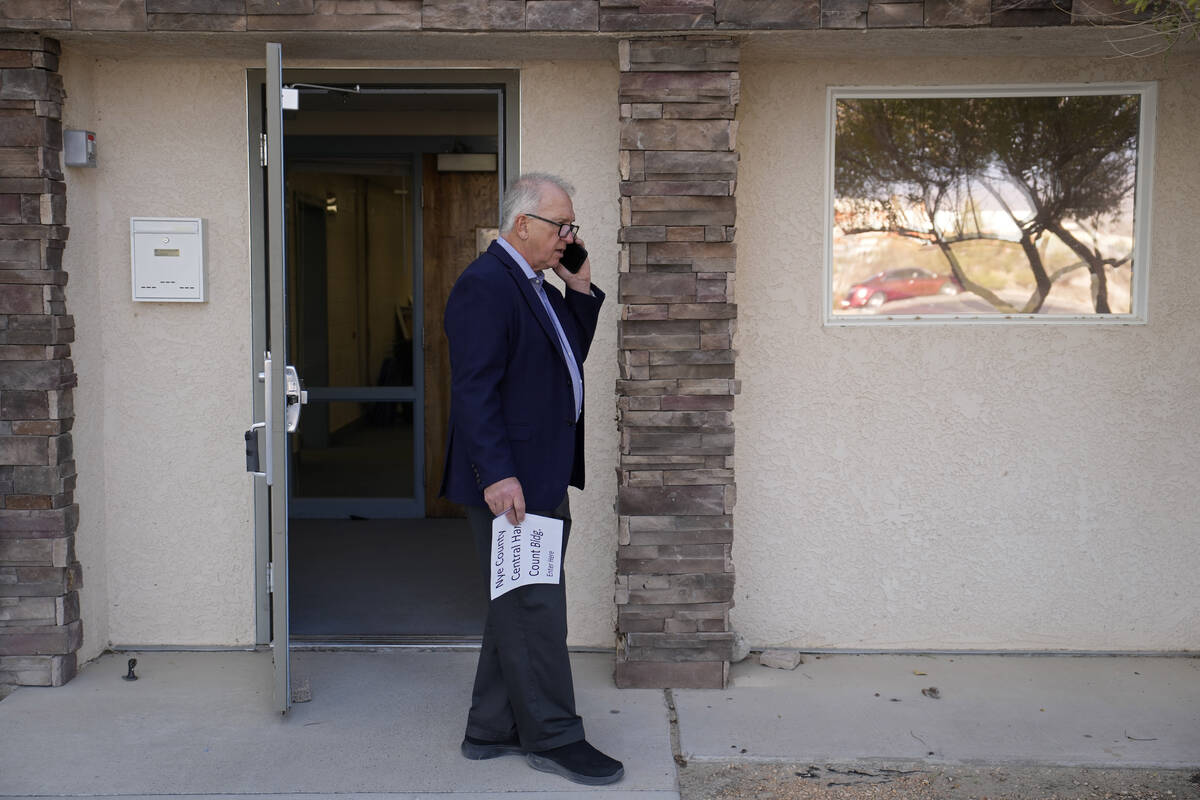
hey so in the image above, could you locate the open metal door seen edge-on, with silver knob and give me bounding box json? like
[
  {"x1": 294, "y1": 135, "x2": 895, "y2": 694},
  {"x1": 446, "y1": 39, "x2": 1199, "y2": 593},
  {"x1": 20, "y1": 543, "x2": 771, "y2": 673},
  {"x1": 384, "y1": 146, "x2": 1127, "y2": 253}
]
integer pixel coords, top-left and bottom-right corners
[{"x1": 262, "y1": 43, "x2": 307, "y2": 712}]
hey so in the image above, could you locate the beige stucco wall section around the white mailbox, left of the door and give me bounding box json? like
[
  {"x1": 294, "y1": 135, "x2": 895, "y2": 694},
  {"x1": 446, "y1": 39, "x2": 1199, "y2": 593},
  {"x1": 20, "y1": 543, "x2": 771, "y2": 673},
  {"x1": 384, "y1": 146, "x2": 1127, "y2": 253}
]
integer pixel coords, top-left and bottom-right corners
[{"x1": 62, "y1": 59, "x2": 254, "y2": 657}]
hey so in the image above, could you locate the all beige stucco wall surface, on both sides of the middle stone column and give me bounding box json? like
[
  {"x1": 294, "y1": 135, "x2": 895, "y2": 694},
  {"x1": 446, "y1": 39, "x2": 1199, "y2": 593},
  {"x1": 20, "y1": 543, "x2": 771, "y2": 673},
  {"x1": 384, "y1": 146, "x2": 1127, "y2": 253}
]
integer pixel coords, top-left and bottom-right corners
[{"x1": 62, "y1": 37, "x2": 1200, "y2": 658}]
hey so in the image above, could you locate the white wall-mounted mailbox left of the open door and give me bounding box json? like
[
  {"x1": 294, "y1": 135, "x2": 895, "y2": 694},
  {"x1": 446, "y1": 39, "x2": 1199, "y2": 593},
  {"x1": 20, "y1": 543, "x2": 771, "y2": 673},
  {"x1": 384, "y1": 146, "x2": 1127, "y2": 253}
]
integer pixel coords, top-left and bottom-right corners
[{"x1": 130, "y1": 217, "x2": 204, "y2": 302}]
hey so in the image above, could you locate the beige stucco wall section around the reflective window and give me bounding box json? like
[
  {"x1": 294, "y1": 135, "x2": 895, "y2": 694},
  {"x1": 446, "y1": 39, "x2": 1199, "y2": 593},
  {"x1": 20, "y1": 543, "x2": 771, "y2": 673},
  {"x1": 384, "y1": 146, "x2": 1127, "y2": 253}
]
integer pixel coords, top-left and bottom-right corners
[{"x1": 733, "y1": 56, "x2": 1200, "y2": 651}]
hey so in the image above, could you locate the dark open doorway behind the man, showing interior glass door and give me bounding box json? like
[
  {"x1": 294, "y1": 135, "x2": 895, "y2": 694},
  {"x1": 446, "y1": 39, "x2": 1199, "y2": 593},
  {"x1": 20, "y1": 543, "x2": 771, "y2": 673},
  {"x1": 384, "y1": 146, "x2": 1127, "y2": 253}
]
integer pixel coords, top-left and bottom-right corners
[{"x1": 253, "y1": 71, "x2": 516, "y2": 644}]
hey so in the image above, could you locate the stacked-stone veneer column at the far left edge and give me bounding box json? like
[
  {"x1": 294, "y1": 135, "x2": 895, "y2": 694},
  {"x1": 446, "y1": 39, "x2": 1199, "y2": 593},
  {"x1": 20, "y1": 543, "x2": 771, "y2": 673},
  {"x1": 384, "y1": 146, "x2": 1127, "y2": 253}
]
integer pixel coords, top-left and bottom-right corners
[{"x1": 0, "y1": 32, "x2": 82, "y2": 686}]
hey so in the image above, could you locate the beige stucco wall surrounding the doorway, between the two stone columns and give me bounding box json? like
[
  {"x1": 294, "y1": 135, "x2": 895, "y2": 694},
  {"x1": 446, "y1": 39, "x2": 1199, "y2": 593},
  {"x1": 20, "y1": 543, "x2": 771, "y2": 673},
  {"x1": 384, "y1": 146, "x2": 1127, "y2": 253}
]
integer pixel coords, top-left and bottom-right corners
[{"x1": 62, "y1": 43, "x2": 618, "y2": 658}]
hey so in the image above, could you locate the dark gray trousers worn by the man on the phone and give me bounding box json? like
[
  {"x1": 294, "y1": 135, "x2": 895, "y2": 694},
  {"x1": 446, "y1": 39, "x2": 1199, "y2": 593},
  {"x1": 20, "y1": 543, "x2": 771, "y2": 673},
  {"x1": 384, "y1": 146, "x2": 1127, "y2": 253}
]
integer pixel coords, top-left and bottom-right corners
[{"x1": 467, "y1": 498, "x2": 583, "y2": 751}]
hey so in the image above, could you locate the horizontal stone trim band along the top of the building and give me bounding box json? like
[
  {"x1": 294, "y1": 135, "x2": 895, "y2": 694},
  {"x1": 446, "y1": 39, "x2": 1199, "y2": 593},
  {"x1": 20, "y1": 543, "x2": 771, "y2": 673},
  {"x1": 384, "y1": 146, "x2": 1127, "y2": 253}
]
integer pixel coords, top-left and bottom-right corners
[{"x1": 0, "y1": 0, "x2": 1134, "y2": 34}]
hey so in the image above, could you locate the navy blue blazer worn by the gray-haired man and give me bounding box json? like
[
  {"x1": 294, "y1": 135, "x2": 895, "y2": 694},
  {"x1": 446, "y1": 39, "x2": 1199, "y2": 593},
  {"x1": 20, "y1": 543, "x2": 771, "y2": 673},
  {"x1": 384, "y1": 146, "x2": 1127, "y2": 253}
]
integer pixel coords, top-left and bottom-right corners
[{"x1": 440, "y1": 241, "x2": 604, "y2": 511}]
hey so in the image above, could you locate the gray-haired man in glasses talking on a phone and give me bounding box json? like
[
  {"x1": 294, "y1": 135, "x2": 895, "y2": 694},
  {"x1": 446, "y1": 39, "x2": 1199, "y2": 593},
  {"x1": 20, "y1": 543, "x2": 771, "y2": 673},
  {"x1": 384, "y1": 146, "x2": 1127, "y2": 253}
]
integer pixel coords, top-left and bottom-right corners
[{"x1": 442, "y1": 173, "x2": 624, "y2": 786}]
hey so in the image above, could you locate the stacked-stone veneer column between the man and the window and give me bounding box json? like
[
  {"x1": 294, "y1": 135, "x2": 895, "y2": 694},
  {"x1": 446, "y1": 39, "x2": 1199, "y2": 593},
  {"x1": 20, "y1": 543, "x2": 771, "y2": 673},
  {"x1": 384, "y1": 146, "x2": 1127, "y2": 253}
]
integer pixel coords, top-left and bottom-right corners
[{"x1": 616, "y1": 36, "x2": 739, "y2": 688}]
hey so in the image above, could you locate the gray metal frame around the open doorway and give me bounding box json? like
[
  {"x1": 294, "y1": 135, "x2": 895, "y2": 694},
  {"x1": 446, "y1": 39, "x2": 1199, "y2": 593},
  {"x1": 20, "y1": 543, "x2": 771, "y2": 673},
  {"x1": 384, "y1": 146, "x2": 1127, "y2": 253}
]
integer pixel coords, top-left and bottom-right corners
[{"x1": 246, "y1": 67, "x2": 521, "y2": 644}]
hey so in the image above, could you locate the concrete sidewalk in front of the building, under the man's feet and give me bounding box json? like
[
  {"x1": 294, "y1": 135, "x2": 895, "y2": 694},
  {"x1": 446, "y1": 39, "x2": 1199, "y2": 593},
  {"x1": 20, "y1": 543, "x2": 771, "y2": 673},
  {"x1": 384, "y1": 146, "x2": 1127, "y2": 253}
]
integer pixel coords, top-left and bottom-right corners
[{"x1": 0, "y1": 650, "x2": 1200, "y2": 800}]
